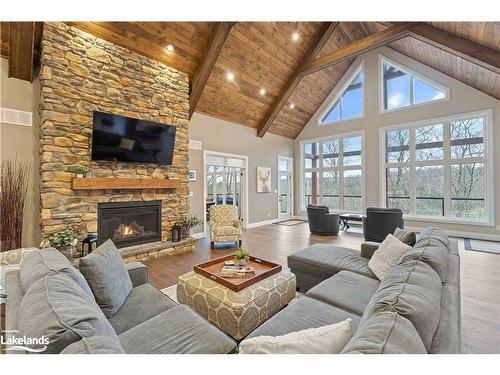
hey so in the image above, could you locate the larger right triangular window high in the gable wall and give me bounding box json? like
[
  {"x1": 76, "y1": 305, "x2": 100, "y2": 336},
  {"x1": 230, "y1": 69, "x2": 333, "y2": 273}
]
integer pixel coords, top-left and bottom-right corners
[{"x1": 382, "y1": 55, "x2": 449, "y2": 111}]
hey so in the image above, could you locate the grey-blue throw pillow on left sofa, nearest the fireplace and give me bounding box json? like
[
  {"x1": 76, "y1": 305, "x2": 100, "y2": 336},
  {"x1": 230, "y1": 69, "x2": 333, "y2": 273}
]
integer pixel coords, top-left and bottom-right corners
[{"x1": 80, "y1": 240, "x2": 132, "y2": 318}]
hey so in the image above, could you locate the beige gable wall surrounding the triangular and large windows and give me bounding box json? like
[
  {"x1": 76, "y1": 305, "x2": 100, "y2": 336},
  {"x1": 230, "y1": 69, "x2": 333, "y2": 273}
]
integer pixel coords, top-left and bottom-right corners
[{"x1": 295, "y1": 47, "x2": 500, "y2": 240}]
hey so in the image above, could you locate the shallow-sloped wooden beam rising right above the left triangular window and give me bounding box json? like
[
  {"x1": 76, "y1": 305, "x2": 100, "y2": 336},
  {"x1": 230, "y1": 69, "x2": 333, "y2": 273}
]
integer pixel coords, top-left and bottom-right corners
[{"x1": 299, "y1": 22, "x2": 418, "y2": 76}]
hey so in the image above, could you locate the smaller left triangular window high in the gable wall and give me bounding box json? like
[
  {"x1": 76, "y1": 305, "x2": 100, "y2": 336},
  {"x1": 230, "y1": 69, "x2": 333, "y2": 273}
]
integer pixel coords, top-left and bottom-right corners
[{"x1": 320, "y1": 67, "x2": 364, "y2": 125}]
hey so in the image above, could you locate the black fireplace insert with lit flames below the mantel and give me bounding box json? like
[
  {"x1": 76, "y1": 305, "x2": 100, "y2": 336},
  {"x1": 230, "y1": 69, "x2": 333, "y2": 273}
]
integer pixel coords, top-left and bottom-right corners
[{"x1": 97, "y1": 201, "x2": 161, "y2": 248}]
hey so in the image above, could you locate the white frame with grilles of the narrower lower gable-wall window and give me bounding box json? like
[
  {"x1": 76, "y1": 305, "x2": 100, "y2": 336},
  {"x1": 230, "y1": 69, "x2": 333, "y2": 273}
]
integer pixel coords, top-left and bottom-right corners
[{"x1": 298, "y1": 130, "x2": 366, "y2": 213}]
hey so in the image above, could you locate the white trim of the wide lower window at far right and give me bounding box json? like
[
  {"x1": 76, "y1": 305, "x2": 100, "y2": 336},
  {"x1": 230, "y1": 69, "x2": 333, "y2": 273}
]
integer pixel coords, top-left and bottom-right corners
[{"x1": 379, "y1": 109, "x2": 495, "y2": 226}]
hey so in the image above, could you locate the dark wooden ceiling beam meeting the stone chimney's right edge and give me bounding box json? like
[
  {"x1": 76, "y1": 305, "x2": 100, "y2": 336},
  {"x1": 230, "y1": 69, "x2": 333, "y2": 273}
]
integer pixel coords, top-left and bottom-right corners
[{"x1": 189, "y1": 22, "x2": 235, "y2": 118}]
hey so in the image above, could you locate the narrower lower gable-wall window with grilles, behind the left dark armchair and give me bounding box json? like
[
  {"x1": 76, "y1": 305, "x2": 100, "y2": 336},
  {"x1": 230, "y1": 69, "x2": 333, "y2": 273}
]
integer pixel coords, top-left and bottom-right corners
[{"x1": 302, "y1": 134, "x2": 364, "y2": 212}]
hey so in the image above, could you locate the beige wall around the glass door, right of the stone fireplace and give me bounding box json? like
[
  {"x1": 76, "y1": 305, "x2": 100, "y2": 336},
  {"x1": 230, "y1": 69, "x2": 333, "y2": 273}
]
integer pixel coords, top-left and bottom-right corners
[{"x1": 189, "y1": 113, "x2": 294, "y2": 232}]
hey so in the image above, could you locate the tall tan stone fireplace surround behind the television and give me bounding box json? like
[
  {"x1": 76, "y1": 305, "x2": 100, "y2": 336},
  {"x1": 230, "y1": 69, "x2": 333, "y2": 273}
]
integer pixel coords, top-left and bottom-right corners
[{"x1": 36, "y1": 22, "x2": 194, "y2": 258}]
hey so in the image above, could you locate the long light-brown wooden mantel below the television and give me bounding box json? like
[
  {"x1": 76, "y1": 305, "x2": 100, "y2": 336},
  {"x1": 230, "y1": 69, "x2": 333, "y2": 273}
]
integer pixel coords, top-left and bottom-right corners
[{"x1": 71, "y1": 177, "x2": 181, "y2": 190}]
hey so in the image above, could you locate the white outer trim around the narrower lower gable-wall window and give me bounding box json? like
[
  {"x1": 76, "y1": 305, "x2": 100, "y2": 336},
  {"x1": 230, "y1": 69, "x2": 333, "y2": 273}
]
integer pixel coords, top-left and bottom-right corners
[{"x1": 299, "y1": 130, "x2": 366, "y2": 214}]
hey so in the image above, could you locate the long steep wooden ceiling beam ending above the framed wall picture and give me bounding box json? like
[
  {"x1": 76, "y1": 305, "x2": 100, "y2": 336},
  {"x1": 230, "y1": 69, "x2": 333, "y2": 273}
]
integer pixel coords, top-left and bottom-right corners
[{"x1": 257, "y1": 22, "x2": 338, "y2": 138}]
